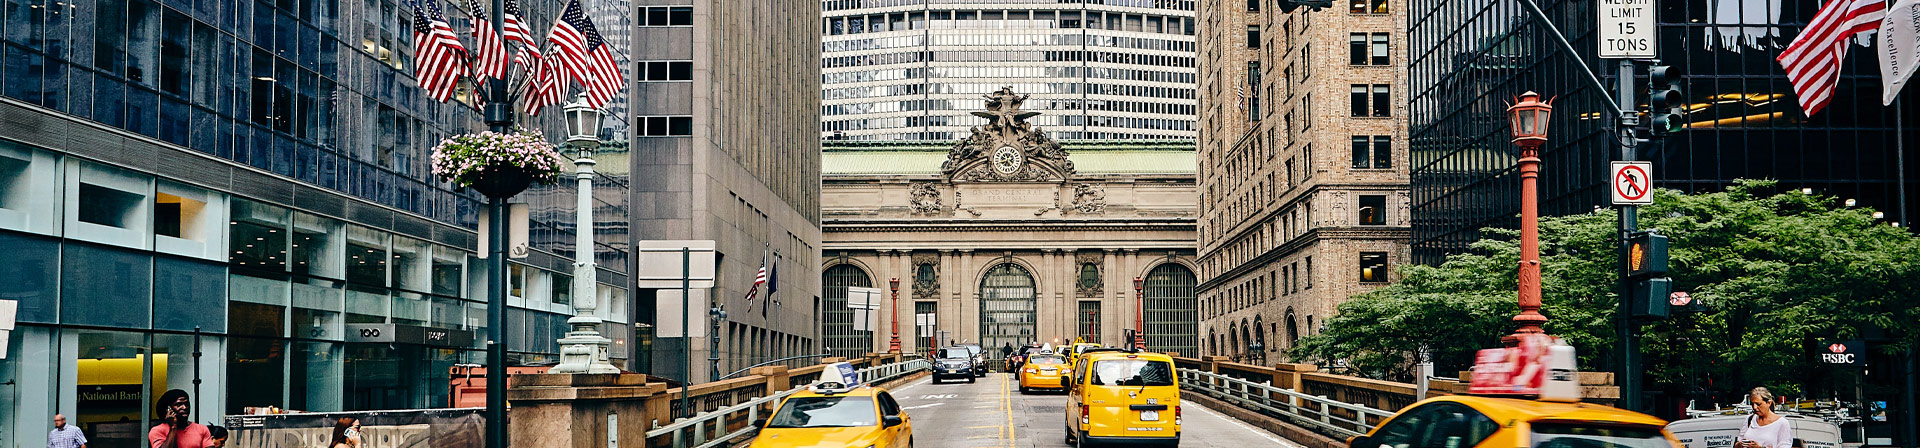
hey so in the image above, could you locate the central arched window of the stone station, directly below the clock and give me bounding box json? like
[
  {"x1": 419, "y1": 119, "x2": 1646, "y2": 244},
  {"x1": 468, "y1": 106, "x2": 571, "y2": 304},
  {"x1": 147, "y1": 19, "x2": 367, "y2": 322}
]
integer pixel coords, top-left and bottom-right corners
[{"x1": 979, "y1": 263, "x2": 1037, "y2": 354}]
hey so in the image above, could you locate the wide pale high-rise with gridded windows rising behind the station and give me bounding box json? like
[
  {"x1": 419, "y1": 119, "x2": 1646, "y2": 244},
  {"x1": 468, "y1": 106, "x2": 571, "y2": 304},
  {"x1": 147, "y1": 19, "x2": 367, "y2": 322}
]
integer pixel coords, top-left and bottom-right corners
[{"x1": 820, "y1": 0, "x2": 1198, "y2": 140}]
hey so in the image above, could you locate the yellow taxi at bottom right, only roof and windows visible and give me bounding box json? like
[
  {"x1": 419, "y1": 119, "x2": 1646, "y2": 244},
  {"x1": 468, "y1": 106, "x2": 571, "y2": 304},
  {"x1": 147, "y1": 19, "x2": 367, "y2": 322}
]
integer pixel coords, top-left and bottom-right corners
[{"x1": 1348, "y1": 396, "x2": 1684, "y2": 448}]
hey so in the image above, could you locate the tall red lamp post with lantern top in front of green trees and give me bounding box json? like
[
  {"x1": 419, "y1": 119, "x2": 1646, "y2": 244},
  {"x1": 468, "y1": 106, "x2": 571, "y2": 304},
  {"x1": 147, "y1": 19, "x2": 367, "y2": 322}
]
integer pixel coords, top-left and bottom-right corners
[{"x1": 1507, "y1": 92, "x2": 1553, "y2": 342}]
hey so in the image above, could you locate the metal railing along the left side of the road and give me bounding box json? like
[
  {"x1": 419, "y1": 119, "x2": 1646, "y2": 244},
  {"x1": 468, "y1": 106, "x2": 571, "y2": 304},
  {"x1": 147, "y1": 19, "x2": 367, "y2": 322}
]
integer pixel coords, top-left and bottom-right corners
[{"x1": 647, "y1": 360, "x2": 933, "y2": 448}]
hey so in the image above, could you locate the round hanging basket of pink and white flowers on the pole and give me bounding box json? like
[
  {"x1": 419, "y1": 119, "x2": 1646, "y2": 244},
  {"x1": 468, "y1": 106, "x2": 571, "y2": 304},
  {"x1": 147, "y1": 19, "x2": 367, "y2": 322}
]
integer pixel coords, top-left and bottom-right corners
[{"x1": 434, "y1": 129, "x2": 566, "y2": 198}]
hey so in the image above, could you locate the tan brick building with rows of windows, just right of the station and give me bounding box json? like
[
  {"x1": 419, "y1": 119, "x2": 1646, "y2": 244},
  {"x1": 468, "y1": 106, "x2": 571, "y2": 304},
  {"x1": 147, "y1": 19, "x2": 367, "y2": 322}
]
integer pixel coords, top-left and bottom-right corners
[{"x1": 1196, "y1": 0, "x2": 1409, "y2": 363}]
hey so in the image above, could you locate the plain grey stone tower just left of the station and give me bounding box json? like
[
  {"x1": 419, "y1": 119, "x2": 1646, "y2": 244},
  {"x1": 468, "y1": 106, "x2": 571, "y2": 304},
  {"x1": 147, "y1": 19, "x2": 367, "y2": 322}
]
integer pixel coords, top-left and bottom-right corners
[{"x1": 628, "y1": 0, "x2": 820, "y2": 381}]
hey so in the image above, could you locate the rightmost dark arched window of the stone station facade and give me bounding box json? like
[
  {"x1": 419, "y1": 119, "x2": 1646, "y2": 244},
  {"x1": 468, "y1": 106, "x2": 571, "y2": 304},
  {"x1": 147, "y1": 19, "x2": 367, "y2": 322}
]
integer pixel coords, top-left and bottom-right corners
[{"x1": 1144, "y1": 263, "x2": 1200, "y2": 356}]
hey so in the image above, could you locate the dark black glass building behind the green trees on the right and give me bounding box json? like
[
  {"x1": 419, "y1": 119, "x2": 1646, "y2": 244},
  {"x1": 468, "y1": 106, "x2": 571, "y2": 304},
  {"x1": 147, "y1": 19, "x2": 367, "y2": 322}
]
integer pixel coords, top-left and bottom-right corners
[{"x1": 1407, "y1": 0, "x2": 1920, "y2": 263}]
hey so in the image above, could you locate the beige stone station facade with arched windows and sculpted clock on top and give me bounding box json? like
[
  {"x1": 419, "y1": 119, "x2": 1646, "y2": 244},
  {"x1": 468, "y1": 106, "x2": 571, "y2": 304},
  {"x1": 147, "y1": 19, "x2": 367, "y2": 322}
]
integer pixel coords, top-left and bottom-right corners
[{"x1": 820, "y1": 90, "x2": 1198, "y2": 356}]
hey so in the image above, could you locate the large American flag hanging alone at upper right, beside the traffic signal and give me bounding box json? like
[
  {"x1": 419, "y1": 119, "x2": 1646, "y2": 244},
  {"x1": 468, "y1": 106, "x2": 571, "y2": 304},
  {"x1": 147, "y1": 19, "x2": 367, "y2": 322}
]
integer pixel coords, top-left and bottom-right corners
[{"x1": 1776, "y1": 0, "x2": 1887, "y2": 117}]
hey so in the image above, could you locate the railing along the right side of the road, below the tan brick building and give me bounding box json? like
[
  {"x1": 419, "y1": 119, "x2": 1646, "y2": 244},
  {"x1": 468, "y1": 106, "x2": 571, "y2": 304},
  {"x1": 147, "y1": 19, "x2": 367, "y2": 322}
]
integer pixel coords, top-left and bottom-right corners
[{"x1": 1179, "y1": 369, "x2": 1394, "y2": 438}]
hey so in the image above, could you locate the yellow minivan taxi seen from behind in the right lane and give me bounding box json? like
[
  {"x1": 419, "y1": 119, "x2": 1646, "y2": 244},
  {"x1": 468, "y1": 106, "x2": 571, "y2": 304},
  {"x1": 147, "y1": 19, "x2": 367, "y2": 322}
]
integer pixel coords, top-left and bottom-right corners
[{"x1": 1066, "y1": 348, "x2": 1181, "y2": 446}]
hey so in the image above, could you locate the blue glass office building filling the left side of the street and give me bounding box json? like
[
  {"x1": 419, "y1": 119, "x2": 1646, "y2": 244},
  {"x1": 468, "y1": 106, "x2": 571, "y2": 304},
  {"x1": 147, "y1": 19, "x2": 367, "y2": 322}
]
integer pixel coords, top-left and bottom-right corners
[{"x1": 0, "y1": 0, "x2": 630, "y2": 446}]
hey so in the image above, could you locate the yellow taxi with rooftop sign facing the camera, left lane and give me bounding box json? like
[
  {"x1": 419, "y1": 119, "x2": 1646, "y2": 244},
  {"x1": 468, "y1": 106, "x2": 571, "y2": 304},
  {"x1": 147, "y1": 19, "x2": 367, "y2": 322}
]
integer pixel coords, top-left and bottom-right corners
[{"x1": 751, "y1": 386, "x2": 914, "y2": 448}]
